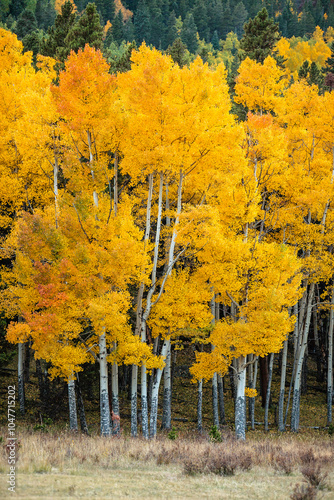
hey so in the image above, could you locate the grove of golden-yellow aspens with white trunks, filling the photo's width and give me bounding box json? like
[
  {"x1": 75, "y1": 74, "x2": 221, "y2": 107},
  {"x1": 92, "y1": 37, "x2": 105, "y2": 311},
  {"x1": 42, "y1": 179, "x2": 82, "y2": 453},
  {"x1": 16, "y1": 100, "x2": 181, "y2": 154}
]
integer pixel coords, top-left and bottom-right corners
[{"x1": 0, "y1": 29, "x2": 334, "y2": 439}]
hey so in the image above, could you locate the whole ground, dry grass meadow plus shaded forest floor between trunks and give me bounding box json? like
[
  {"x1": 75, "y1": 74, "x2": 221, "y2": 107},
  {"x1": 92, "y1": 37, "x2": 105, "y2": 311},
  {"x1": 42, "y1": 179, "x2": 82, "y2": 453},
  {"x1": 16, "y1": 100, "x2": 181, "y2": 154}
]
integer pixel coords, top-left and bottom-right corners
[{"x1": 0, "y1": 350, "x2": 334, "y2": 500}]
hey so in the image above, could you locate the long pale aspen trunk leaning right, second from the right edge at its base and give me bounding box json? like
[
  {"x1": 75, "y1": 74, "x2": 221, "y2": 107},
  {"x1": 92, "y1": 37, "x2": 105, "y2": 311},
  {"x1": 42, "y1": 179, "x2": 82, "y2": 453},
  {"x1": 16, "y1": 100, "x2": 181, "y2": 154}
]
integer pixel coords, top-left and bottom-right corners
[{"x1": 291, "y1": 283, "x2": 314, "y2": 432}]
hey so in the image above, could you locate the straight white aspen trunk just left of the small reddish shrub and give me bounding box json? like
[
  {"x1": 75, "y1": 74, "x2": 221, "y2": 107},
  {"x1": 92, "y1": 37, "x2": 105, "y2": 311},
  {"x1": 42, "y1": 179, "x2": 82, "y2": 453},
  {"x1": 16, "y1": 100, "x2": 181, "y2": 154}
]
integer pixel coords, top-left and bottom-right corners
[{"x1": 99, "y1": 330, "x2": 110, "y2": 436}]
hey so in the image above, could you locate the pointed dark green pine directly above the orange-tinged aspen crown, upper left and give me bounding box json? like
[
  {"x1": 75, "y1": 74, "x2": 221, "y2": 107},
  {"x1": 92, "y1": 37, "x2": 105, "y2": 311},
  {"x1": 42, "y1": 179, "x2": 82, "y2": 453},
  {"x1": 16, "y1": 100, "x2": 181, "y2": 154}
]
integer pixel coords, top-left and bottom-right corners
[{"x1": 65, "y1": 3, "x2": 103, "y2": 52}]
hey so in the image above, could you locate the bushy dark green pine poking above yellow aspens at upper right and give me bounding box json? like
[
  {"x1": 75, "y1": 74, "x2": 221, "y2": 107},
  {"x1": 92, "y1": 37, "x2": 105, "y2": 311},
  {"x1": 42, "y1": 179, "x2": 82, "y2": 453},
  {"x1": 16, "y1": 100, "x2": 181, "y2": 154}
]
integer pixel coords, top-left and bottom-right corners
[{"x1": 240, "y1": 8, "x2": 280, "y2": 63}]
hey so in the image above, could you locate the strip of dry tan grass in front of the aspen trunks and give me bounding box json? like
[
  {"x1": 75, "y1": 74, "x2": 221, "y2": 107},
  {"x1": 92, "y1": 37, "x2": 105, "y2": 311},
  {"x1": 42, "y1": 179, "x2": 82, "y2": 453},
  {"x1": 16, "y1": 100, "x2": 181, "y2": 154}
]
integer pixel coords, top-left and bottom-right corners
[{"x1": 0, "y1": 429, "x2": 334, "y2": 500}]
